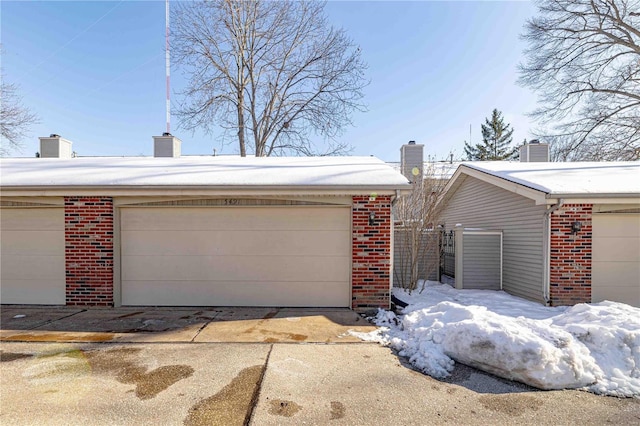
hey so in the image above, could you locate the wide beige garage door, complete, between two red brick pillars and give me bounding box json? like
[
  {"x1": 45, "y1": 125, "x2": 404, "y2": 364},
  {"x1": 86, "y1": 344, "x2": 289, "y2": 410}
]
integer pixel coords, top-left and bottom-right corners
[{"x1": 120, "y1": 206, "x2": 351, "y2": 307}]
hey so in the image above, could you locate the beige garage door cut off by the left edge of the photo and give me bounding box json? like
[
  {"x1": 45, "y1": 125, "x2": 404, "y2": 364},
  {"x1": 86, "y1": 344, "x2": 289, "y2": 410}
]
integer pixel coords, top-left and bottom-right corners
[{"x1": 0, "y1": 208, "x2": 65, "y2": 305}]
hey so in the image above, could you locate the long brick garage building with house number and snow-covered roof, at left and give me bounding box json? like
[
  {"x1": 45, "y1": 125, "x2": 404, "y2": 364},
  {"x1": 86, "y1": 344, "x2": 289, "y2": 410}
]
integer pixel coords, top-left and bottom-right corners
[{"x1": 0, "y1": 143, "x2": 411, "y2": 312}]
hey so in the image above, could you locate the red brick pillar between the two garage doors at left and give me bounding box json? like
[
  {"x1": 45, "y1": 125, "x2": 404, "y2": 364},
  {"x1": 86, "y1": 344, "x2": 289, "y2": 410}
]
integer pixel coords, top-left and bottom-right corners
[{"x1": 64, "y1": 197, "x2": 113, "y2": 306}]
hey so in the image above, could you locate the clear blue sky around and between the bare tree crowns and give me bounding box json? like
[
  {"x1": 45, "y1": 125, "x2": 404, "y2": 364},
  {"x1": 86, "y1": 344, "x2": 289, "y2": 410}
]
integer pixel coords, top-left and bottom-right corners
[{"x1": 0, "y1": 0, "x2": 535, "y2": 161}]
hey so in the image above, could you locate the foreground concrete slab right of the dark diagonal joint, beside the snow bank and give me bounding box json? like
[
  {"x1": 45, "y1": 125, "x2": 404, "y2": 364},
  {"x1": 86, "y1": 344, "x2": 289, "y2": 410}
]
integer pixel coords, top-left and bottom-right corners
[{"x1": 251, "y1": 344, "x2": 640, "y2": 426}]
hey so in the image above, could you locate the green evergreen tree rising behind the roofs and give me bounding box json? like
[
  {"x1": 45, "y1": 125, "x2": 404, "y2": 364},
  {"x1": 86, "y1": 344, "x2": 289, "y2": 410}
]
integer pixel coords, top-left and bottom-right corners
[{"x1": 464, "y1": 109, "x2": 518, "y2": 161}]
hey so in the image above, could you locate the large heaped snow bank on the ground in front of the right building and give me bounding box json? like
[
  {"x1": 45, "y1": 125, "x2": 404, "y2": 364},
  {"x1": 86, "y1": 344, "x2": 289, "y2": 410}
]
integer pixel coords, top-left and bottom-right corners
[{"x1": 353, "y1": 282, "x2": 640, "y2": 397}]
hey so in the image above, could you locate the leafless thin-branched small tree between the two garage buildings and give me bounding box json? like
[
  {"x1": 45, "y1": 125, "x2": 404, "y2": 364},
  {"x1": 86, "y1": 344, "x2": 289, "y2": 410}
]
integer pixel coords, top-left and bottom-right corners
[{"x1": 393, "y1": 162, "x2": 454, "y2": 291}]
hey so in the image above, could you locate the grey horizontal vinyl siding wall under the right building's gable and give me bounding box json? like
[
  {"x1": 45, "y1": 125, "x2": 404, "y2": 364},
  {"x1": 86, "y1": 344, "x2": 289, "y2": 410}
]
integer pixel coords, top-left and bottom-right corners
[{"x1": 441, "y1": 176, "x2": 546, "y2": 302}]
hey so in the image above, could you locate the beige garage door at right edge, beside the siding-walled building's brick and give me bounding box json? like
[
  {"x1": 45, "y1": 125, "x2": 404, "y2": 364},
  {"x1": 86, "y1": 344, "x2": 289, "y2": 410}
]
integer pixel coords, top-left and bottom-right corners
[{"x1": 591, "y1": 213, "x2": 640, "y2": 307}]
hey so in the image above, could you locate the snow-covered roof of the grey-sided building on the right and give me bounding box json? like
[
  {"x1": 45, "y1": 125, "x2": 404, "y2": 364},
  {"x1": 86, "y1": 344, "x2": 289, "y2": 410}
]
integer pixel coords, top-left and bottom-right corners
[{"x1": 450, "y1": 161, "x2": 640, "y2": 198}]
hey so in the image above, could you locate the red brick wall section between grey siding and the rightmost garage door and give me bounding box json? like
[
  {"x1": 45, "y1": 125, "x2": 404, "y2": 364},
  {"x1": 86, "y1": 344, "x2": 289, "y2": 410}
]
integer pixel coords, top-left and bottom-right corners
[{"x1": 549, "y1": 204, "x2": 592, "y2": 306}]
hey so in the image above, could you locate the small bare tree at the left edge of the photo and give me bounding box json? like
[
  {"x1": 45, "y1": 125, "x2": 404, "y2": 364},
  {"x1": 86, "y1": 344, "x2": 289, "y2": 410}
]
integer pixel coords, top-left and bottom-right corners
[{"x1": 0, "y1": 75, "x2": 39, "y2": 156}]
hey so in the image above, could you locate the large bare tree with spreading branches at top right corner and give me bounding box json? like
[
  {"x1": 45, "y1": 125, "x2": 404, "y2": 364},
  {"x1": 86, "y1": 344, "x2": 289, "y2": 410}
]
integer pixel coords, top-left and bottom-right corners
[{"x1": 519, "y1": 0, "x2": 640, "y2": 160}]
